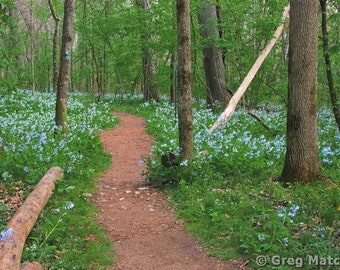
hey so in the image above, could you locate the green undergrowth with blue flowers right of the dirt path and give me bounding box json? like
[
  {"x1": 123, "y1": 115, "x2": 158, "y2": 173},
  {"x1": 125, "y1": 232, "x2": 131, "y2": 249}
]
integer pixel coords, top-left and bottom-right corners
[{"x1": 107, "y1": 94, "x2": 340, "y2": 269}]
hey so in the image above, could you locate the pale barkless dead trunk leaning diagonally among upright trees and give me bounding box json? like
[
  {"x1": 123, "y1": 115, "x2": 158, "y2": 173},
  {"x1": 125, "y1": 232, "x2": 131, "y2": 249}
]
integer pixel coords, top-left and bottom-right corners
[{"x1": 209, "y1": 5, "x2": 289, "y2": 132}]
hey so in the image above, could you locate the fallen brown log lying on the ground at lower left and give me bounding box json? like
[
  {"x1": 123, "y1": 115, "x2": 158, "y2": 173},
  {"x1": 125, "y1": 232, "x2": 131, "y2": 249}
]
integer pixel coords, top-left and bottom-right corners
[{"x1": 0, "y1": 167, "x2": 63, "y2": 270}]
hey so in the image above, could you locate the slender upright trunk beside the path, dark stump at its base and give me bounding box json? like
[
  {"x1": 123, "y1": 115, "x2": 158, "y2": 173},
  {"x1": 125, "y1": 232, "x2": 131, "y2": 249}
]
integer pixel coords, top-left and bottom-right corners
[{"x1": 177, "y1": 0, "x2": 193, "y2": 160}]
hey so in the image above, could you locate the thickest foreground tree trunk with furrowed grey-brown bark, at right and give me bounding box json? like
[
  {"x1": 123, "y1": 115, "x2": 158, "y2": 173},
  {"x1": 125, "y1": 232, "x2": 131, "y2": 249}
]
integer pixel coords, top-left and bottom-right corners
[{"x1": 281, "y1": 0, "x2": 320, "y2": 183}]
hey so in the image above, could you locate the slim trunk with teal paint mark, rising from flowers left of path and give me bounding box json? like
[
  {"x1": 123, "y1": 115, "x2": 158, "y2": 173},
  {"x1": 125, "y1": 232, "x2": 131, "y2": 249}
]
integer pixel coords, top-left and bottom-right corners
[{"x1": 55, "y1": 0, "x2": 74, "y2": 134}]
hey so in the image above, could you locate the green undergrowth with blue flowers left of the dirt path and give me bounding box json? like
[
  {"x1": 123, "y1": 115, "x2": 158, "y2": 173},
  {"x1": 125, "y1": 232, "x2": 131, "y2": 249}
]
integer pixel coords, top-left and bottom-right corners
[{"x1": 0, "y1": 91, "x2": 118, "y2": 270}]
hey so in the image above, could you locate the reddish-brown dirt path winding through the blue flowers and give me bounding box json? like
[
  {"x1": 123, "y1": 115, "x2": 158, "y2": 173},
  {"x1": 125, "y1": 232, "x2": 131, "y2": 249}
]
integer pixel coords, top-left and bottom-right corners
[{"x1": 94, "y1": 113, "x2": 240, "y2": 270}]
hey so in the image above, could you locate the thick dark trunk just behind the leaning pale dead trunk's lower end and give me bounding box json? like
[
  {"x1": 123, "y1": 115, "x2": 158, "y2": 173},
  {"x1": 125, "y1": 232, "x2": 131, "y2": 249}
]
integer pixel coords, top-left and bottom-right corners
[{"x1": 198, "y1": 0, "x2": 229, "y2": 105}]
